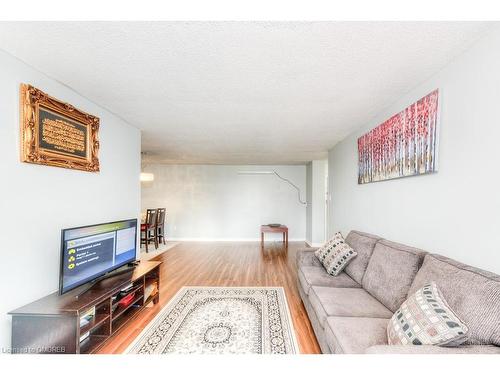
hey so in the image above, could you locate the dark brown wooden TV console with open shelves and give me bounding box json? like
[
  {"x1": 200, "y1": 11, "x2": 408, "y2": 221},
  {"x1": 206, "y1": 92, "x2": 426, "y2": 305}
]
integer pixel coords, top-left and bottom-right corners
[{"x1": 9, "y1": 261, "x2": 162, "y2": 354}]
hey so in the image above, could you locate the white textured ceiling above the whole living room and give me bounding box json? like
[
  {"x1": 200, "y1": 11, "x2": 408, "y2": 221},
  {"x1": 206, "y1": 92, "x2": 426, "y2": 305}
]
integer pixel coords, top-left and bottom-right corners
[{"x1": 0, "y1": 22, "x2": 492, "y2": 164}]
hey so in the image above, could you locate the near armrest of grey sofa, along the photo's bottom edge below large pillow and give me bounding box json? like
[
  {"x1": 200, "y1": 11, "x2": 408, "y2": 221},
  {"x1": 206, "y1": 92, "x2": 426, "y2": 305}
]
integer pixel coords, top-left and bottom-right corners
[{"x1": 365, "y1": 345, "x2": 500, "y2": 354}]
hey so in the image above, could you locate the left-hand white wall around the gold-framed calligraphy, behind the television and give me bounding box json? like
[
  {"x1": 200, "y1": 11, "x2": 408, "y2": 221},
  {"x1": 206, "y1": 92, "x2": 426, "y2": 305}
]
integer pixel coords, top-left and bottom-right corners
[{"x1": 0, "y1": 51, "x2": 140, "y2": 352}]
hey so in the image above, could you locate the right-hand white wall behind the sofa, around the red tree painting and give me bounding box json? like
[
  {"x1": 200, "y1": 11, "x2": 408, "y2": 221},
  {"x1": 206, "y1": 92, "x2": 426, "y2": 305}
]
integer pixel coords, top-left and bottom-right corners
[{"x1": 329, "y1": 26, "x2": 500, "y2": 273}]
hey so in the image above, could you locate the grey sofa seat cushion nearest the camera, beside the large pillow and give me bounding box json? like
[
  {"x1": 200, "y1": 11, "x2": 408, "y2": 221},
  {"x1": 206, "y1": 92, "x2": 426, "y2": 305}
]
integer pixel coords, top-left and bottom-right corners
[{"x1": 325, "y1": 316, "x2": 389, "y2": 354}]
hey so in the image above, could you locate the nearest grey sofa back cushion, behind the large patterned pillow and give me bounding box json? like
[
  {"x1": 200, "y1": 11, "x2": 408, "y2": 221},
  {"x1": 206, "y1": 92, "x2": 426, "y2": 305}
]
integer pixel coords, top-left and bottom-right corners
[{"x1": 410, "y1": 254, "x2": 500, "y2": 345}]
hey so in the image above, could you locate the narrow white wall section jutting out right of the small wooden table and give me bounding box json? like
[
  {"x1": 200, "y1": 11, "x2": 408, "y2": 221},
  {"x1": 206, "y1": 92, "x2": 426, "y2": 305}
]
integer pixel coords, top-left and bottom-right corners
[{"x1": 306, "y1": 160, "x2": 327, "y2": 246}]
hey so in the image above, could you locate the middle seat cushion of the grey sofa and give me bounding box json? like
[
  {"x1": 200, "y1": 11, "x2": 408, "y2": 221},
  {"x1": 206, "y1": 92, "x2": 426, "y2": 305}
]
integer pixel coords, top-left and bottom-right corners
[{"x1": 309, "y1": 286, "x2": 392, "y2": 327}]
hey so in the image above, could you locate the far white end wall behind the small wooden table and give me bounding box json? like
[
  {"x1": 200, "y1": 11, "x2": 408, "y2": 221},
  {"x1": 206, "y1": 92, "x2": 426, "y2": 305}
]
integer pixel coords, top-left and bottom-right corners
[{"x1": 141, "y1": 164, "x2": 306, "y2": 241}]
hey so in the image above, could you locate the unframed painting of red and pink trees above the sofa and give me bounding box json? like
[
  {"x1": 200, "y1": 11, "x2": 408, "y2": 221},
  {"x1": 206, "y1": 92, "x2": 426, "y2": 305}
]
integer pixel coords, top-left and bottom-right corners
[{"x1": 358, "y1": 90, "x2": 439, "y2": 184}]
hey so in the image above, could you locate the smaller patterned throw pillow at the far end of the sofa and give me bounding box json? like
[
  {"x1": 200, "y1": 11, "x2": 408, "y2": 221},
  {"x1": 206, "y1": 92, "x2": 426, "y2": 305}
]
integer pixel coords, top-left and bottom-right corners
[{"x1": 314, "y1": 232, "x2": 358, "y2": 276}]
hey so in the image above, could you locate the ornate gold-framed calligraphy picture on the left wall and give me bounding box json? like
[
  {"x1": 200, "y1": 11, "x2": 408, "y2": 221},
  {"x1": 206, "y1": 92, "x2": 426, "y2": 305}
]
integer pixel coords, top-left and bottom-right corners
[{"x1": 20, "y1": 84, "x2": 99, "y2": 172}]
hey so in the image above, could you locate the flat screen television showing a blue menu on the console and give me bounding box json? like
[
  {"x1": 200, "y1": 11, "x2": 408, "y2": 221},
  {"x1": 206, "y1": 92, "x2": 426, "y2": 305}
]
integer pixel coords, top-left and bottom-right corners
[{"x1": 59, "y1": 219, "x2": 137, "y2": 294}]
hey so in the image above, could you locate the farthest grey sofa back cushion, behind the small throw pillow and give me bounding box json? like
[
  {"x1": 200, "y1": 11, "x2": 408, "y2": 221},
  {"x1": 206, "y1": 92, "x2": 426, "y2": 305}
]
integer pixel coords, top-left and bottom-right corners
[{"x1": 344, "y1": 230, "x2": 381, "y2": 284}]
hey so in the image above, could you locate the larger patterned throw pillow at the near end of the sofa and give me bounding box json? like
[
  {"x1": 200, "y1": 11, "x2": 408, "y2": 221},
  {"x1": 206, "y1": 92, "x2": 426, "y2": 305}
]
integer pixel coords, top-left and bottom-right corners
[{"x1": 387, "y1": 282, "x2": 468, "y2": 346}]
